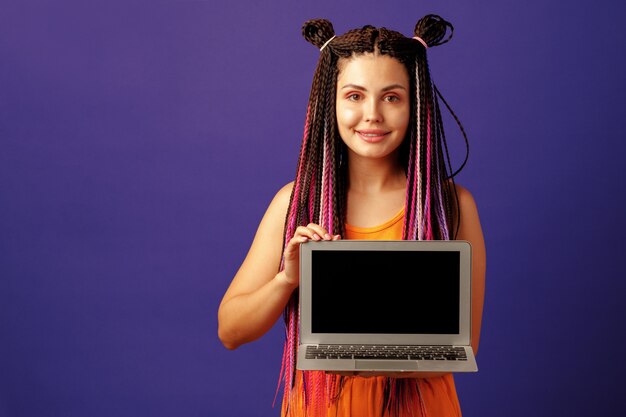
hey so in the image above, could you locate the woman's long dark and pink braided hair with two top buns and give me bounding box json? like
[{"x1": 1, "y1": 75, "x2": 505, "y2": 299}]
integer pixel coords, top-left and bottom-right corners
[{"x1": 281, "y1": 15, "x2": 469, "y2": 415}]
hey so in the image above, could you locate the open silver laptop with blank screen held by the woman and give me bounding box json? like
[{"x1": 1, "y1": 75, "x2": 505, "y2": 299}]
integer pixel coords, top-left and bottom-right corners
[{"x1": 296, "y1": 240, "x2": 478, "y2": 375}]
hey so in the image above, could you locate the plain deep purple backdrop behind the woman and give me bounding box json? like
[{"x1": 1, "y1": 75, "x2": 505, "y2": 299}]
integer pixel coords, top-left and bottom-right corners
[{"x1": 0, "y1": 0, "x2": 626, "y2": 417}]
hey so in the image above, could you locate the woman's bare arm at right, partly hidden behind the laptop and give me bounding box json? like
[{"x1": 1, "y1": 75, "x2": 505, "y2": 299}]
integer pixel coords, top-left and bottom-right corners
[{"x1": 456, "y1": 185, "x2": 486, "y2": 354}]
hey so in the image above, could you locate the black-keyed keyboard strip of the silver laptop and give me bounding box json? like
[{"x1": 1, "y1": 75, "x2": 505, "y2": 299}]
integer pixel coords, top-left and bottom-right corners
[{"x1": 306, "y1": 345, "x2": 467, "y2": 361}]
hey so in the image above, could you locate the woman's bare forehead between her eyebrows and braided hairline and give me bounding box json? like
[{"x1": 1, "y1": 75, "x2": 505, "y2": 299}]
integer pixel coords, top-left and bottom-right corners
[{"x1": 337, "y1": 54, "x2": 409, "y2": 88}]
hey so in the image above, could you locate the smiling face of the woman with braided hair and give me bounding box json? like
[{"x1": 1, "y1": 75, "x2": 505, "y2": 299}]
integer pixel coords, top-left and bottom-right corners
[{"x1": 336, "y1": 54, "x2": 411, "y2": 158}]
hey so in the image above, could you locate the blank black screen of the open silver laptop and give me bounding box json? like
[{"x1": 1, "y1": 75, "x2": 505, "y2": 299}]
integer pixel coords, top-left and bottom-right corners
[{"x1": 311, "y1": 250, "x2": 460, "y2": 334}]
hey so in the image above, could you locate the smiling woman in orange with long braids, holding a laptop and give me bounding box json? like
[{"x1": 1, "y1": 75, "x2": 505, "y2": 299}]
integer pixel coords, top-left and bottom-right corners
[{"x1": 218, "y1": 15, "x2": 485, "y2": 417}]
